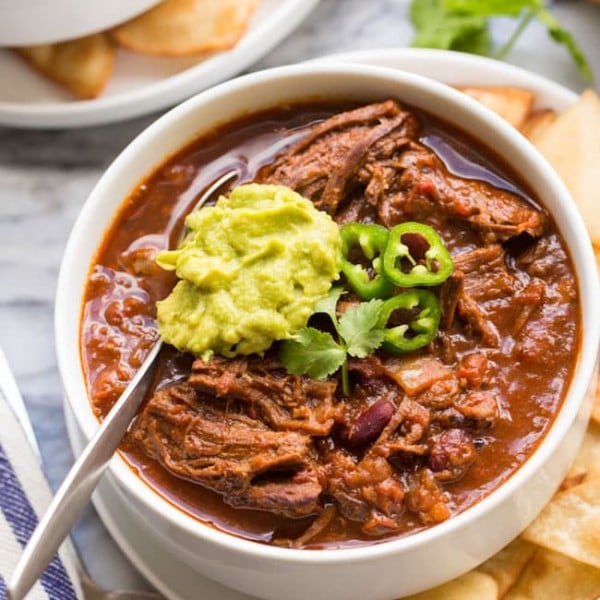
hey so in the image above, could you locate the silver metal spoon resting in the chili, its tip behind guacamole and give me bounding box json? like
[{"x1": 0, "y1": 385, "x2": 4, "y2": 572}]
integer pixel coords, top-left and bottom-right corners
[{"x1": 7, "y1": 171, "x2": 238, "y2": 600}]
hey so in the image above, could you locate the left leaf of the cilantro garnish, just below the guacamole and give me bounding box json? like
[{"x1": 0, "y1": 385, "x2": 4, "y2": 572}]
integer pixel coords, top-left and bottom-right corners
[{"x1": 280, "y1": 327, "x2": 346, "y2": 379}]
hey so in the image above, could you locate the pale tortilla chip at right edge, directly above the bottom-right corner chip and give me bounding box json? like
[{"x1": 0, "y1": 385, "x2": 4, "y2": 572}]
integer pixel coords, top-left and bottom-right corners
[{"x1": 523, "y1": 478, "x2": 600, "y2": 568}]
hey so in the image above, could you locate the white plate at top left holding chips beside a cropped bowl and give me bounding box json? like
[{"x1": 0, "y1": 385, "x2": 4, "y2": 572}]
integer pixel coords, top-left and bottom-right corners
[{"x1": 0, "y1": 0, "x2": 319, "y2": 128}]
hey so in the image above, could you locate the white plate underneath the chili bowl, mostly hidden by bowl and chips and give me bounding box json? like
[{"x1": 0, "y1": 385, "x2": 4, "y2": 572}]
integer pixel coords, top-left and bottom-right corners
[{"x1": 65, "y1": 49, "x2": 576, "y2": 600}]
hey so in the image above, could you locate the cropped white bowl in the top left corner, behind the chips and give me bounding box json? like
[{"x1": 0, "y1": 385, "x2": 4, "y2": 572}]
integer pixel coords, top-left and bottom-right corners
[{"x1": 0, "y1": 0, "x2": 160, "y2": 46}]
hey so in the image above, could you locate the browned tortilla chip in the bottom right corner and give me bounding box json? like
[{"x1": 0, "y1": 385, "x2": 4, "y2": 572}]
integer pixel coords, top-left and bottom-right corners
[{"x1": 504, "y1": 548, "x2": 600, "y2": 600}]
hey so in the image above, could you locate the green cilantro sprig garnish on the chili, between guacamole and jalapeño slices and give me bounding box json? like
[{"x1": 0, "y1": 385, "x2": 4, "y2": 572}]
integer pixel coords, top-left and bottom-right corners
[{"x1": 280, "y1": 287, "x2": 383, "y2": 395}]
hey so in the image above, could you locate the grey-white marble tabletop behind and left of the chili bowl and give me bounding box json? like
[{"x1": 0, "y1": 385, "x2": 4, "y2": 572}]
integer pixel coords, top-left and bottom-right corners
[{"x1": 0, "y1": 0, "x2": 600, "y2": 588}]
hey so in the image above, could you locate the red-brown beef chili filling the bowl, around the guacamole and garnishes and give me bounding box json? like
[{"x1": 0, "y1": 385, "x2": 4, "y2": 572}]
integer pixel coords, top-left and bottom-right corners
[{"x1": 81, "y1": 101, "x2": 580, "y2": 548}]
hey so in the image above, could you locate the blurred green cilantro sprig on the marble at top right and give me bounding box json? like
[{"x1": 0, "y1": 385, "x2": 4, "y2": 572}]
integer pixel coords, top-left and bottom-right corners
[{"x1": 410, "y1": 0, "x2": 592, "y2": 81}]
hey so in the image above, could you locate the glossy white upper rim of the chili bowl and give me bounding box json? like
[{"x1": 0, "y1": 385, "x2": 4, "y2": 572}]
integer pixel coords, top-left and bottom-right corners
[{"x1": 55, "y1": 61, "x2": 600, "y2": 564}]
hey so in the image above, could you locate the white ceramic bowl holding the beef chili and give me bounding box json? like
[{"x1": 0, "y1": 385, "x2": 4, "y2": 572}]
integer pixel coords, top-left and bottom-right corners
[{"x1": 55, "y1": 64, "x2": 600, "y2": 600}]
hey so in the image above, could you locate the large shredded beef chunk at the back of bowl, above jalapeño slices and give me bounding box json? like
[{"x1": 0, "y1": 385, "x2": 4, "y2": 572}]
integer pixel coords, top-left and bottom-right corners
[{"x1": 259, "y1": 100, "x2": 545, "y2": 242}]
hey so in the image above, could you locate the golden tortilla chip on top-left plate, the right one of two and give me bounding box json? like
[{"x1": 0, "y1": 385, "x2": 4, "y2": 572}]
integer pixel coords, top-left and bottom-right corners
[{"x1": 111, "y1": 0, "x2": 258, "y2": 56}]
